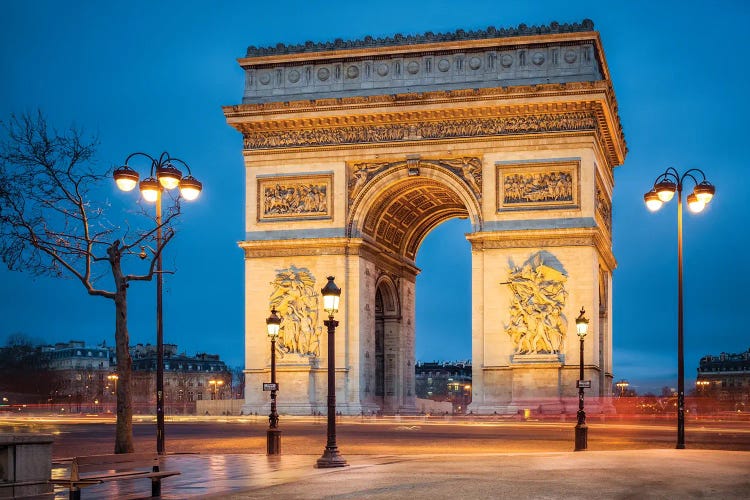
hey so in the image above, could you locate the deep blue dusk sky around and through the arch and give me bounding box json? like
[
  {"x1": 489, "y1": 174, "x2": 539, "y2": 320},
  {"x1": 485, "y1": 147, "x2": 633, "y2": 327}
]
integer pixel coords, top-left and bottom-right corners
[{"x1": 0, "y1": 0, "x2": 750, "y2": 392}]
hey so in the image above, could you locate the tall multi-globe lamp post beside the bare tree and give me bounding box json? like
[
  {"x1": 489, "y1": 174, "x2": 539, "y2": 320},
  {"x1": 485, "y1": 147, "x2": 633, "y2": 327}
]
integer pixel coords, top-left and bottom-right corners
[{"x1": 113, "y1": 151, "x2": 203, "y2": 455}]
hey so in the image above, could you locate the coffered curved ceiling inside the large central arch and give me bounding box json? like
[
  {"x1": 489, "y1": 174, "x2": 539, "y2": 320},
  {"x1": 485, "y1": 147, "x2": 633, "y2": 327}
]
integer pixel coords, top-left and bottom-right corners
[{"x1": 362, "y1": 177, "x2": 469, "y2": 261}]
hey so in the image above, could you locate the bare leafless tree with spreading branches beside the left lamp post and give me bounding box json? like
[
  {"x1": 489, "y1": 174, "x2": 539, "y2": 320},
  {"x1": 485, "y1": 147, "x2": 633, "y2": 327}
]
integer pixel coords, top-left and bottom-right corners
[{"x1": 0, "y1": 112, "x2": 180, "y2": 453}]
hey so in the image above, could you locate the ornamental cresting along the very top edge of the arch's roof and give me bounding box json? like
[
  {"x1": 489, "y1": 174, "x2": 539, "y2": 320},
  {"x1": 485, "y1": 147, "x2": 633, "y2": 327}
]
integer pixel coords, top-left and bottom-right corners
[{"x1": 246, "y1": 19, "x2": 594, "y2": 57}]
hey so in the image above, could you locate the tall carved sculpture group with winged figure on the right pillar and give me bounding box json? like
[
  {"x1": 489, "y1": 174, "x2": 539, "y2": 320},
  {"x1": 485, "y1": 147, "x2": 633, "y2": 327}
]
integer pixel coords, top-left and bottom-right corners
[{"x1": 505, "y1": 252, "x2": 568, "y2": 354}]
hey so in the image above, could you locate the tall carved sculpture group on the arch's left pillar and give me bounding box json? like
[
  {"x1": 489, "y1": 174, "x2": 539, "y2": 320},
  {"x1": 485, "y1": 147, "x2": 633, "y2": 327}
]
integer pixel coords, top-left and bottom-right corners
[{"x1": 269, "y1": 266, "x2": 321, "y2": 357}]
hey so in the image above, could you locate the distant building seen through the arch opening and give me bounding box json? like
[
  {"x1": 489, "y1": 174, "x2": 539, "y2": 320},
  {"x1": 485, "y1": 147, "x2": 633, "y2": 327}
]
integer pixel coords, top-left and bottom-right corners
[{"x1": 414, "y1": 361, "x2": 471, "y2": 413}]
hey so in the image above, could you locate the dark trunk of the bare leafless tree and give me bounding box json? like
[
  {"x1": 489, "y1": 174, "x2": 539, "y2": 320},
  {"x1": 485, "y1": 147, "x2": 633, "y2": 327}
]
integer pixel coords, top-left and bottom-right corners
[{"x1": 110, "y1": 248, "x2": 134, "y2": 453}]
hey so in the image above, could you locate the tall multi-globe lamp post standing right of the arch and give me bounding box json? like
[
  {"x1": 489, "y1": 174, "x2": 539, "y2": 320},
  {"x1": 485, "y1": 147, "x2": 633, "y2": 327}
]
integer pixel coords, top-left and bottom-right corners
[{"x1": 643, "y1": 167, "x2": 716, "y2": 449}]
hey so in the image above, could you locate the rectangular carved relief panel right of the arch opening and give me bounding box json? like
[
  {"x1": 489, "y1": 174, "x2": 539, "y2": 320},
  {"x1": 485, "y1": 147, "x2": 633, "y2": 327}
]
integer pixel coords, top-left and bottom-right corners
[{"x1": 497, "y1": 160, "x2": 580, "y2": 212}]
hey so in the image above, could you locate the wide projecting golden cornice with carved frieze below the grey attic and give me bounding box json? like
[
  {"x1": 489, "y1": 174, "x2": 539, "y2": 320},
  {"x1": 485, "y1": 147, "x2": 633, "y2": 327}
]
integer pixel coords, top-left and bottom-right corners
[{"x1": 224, "y1": 82, "x2": 627, "y2": 167}]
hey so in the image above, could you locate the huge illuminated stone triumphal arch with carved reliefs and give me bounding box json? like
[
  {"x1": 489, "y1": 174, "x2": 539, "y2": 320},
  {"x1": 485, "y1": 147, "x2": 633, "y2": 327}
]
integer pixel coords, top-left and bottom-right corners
[{"x1": 224, "y1": 20, "x2": 626, "y2": 414}]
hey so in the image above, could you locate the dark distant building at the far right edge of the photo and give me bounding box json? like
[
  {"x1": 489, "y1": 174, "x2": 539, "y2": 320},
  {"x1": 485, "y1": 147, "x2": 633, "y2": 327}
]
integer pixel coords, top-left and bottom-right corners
[{"x1": 696, "y1": 349, "x2": 750, "y2": 405}]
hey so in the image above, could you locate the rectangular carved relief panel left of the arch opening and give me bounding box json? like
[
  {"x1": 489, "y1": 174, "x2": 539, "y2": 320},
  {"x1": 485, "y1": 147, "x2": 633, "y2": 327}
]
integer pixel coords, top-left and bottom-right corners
[{"x1": 258, "y1": 174, "x2": 333, "y2": 222}]
